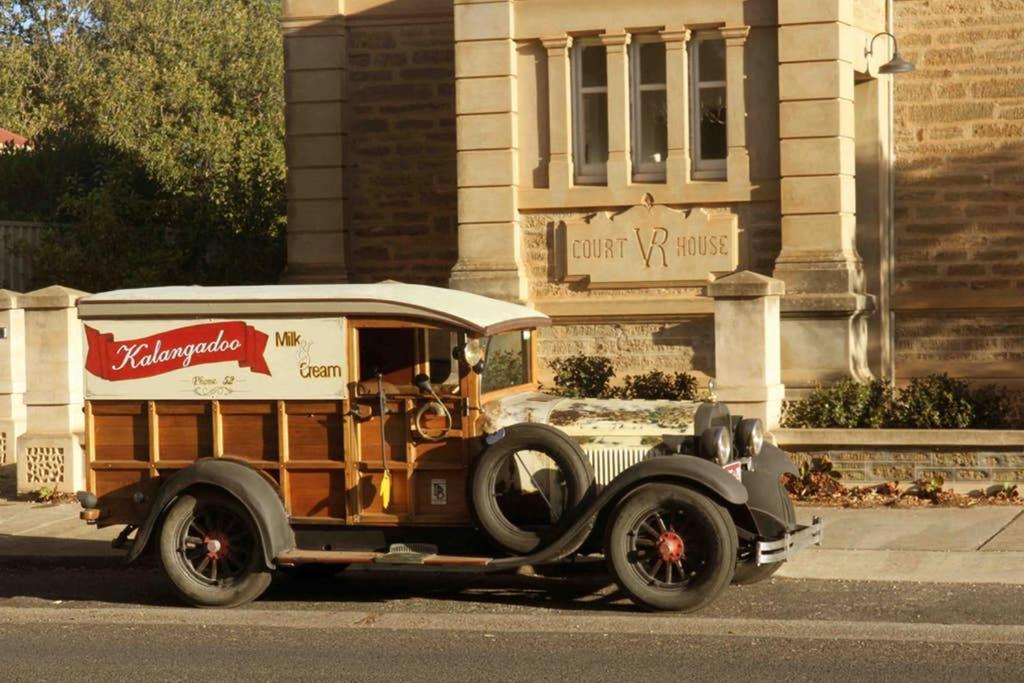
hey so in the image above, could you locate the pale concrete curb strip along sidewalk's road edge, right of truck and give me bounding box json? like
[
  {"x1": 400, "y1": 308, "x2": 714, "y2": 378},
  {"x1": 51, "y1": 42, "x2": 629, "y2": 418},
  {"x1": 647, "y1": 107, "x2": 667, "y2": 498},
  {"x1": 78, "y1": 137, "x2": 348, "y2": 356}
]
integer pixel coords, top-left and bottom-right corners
[{"x1": 775, "y1": 548, "x2": 1024, "y2": 585}]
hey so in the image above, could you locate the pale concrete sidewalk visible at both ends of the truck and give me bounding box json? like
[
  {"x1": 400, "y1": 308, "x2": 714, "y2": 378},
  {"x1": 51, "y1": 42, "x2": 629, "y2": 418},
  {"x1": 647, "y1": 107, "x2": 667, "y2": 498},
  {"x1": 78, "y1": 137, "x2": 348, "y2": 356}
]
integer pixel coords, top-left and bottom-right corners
[{"x1": 0, "y1": 499, "x2": 1024, "y2": 585}]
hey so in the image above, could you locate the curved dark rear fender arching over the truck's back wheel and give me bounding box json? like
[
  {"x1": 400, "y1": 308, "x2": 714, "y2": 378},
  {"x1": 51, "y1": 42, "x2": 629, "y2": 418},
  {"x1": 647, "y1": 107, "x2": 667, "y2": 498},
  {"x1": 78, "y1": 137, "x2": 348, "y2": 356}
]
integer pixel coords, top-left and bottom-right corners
[{"x1": 128, "y1": 458, "x2": 295, "y2": 569}]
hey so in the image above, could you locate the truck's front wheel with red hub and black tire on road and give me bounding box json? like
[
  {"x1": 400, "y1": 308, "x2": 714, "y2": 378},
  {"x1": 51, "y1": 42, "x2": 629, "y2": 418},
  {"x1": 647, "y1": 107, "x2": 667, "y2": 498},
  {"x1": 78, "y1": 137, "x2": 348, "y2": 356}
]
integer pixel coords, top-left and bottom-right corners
[{"x1": 605, "y1": 483, "x2": 737, "y2": 612}]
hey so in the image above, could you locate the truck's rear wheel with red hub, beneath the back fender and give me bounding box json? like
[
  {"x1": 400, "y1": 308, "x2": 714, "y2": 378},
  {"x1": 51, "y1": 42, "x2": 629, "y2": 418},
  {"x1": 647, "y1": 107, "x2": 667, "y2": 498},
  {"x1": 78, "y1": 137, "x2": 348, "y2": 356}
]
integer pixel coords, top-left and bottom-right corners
[{"x1": 160, "y1": 492, "x2": 271, "y2": 607}]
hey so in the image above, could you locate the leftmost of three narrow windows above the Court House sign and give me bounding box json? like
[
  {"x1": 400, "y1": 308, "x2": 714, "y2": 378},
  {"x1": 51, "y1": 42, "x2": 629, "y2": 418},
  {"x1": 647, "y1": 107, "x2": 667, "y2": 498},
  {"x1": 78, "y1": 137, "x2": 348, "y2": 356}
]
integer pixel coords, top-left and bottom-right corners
[{"x1": 571, "y1": 40, "x2": 608, "y2": 184}]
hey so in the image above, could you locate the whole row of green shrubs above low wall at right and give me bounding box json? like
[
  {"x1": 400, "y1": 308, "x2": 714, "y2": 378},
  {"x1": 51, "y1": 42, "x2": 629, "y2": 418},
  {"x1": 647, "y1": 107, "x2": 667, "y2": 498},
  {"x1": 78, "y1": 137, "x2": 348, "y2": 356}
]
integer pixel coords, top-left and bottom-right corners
[{"x1": 782, "y1": 374, "x2": 1010, "y2": 429}]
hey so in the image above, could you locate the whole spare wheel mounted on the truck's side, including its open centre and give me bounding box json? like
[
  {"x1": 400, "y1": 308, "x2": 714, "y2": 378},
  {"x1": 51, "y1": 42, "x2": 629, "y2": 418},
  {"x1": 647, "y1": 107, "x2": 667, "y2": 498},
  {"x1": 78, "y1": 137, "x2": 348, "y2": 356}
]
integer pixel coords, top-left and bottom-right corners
[{"x1": 470, "y1": 423, "x2": 594, "y2": 555}]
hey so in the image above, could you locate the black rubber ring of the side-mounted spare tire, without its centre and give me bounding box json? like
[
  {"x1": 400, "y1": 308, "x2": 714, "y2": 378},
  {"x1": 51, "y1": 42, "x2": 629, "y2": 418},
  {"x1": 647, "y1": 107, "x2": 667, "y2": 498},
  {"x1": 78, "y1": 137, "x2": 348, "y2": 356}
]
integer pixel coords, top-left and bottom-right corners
[{"x1": 470, "y1": 423, "x2": 594, "y2": 555}]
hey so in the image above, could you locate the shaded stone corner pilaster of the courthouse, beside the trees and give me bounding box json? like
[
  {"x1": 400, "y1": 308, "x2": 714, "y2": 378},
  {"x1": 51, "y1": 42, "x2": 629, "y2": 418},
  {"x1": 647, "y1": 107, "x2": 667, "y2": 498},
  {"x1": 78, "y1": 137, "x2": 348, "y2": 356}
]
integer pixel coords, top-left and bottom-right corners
[{"x1": 281, "y1": 0, "x2": 347, "y2": 283}]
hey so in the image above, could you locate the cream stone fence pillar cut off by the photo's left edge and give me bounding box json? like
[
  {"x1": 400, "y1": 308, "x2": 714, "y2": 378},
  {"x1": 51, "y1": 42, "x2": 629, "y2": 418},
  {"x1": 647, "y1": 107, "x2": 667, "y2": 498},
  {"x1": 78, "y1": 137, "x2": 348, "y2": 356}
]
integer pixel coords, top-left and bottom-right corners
[{"x1": 0, "y1": 290, "x2": 26, "y2": 467}]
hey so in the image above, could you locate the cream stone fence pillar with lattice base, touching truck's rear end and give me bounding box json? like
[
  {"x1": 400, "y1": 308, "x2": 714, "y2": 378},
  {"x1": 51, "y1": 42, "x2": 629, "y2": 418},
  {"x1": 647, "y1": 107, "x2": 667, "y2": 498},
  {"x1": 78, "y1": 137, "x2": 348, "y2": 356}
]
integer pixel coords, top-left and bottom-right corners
[{"x1": 17, "y1": 285, "x2": 85, "y2": 494}]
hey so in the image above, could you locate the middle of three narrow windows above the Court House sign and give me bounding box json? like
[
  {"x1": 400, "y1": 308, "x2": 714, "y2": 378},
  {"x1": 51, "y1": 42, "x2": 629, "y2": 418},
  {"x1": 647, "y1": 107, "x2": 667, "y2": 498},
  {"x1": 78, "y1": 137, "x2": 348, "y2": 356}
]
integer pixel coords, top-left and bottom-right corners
[{"x1": 630, "y1": 35, "x2": 669, "y2": 182}]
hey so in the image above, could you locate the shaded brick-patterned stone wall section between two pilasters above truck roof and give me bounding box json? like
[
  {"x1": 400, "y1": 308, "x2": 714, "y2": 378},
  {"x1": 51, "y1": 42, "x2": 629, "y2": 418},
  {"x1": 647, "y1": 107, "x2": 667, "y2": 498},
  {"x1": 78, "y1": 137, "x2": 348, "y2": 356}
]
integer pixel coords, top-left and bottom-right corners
[{"x1": 346, "y1": 18, "x2": 458, "y2": 286}]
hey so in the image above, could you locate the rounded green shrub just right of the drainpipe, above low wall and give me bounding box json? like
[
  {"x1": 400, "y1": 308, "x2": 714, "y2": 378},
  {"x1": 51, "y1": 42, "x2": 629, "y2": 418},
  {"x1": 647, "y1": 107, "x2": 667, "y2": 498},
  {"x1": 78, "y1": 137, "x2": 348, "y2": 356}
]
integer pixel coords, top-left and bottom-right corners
[{"x1": 894, "y1": 374, "x2": 975, "y2": 429}]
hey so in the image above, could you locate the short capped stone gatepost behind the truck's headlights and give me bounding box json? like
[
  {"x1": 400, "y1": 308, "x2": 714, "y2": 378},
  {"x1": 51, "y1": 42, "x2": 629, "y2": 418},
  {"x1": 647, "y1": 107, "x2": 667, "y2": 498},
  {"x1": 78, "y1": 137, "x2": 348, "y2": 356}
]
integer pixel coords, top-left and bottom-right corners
[{"x1": 708, "y1": 270, "x2": 785, "y2": 429}]
